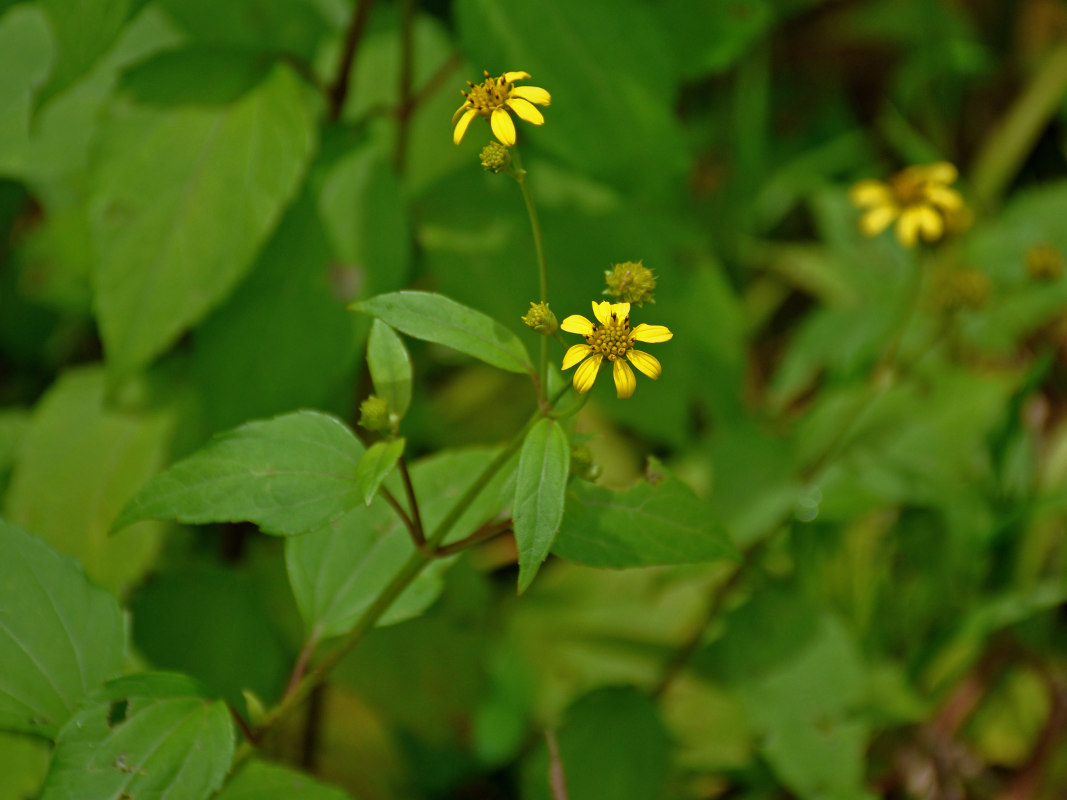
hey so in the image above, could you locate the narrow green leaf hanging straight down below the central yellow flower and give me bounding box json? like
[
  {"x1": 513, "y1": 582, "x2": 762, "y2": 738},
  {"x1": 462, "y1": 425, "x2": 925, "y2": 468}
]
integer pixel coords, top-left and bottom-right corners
[{"x1": 512, "y1": 418, "x2": 571, "y2": 594}]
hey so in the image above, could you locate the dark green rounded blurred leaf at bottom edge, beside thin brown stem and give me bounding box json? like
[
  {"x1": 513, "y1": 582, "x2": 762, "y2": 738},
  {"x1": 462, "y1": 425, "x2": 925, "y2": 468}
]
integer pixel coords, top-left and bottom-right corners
[{"x1": 523, "y1": 687, "x2": 672, "y2": 800}]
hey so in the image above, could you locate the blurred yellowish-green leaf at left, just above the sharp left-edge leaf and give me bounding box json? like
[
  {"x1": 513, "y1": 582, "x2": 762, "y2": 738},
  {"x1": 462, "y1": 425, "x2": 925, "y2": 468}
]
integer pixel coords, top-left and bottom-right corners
[{"x1": 4, "y1": 367, "x2": 177, "y2": 592}]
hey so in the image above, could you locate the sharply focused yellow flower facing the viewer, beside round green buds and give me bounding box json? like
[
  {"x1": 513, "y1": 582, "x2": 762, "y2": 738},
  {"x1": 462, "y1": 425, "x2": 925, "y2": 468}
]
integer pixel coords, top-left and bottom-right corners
[{"x1": 560, "y1": 300, "x2": 674, "y2": 398}]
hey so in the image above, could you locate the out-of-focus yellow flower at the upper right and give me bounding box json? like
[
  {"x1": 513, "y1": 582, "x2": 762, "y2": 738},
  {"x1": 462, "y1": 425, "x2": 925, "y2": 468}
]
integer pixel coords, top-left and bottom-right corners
[{"x1": 848, "y1": 161, "x2": 969, "y2": 247}]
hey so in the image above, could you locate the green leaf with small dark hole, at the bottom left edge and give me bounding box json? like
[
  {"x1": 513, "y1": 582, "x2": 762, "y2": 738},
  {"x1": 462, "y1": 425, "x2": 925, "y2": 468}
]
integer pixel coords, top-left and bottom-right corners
[{"x1": 41, "y1": 672, "x2": 234, "y2": 800}]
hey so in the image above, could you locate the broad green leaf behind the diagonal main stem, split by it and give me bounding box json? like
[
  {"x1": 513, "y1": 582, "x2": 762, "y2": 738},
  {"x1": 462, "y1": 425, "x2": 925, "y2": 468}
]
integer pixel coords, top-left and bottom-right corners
[{"x1": 285, "y1": 449, "x2": 513, "y2": 638}]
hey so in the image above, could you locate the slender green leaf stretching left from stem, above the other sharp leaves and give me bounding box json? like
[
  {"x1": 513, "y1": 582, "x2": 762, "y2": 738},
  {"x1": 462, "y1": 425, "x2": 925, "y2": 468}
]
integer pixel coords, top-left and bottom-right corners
[{"x1": 350, "y1": 291, "x2": 534, "y2": 372}]
